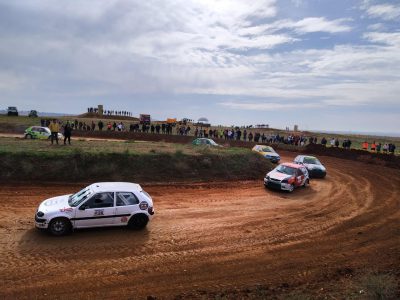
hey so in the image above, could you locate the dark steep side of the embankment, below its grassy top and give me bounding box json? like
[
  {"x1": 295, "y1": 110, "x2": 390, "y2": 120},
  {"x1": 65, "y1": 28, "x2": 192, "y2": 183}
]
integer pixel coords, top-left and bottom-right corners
[{"x1": 0, "y1": 152, "x2": 272, "y2": 182}]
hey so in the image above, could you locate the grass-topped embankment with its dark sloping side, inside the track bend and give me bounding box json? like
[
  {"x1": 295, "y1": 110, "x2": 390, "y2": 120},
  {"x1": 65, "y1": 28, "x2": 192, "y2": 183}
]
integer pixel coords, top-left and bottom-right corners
[{"x1": 0, "y1": 138, "x2": 272, "y2": 182}]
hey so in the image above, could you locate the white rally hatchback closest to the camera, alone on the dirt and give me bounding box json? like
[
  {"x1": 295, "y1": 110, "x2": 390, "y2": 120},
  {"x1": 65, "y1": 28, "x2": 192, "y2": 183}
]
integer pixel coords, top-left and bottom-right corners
[{"x1": 35, "y1": 182, "x2": 154, "y2": 235}]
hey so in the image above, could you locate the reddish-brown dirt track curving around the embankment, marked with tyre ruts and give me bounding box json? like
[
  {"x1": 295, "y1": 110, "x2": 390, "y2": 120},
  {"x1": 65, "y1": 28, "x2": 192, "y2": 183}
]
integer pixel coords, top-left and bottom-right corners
[{"x1": 0, "y1": 153, "x2": 400, "y2": 299}]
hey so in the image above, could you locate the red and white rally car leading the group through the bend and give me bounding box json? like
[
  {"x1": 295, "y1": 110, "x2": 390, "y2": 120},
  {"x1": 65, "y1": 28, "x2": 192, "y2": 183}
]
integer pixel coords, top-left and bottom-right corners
[{"x1": 264, "y1": 163, "x2": 310, "y2": 192}]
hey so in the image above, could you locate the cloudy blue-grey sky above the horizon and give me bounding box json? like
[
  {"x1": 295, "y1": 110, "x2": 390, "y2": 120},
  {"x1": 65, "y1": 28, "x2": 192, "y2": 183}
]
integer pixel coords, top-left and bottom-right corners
[{"x1": 0, "y1": 0, "x2": 400, "y2": 132}]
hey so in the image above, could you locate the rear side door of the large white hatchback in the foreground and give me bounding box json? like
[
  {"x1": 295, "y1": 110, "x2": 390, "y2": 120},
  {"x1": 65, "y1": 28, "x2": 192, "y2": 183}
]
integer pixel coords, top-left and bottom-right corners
[{"x1": 115, "y1": 192, "x2": 140, "y2": 225}]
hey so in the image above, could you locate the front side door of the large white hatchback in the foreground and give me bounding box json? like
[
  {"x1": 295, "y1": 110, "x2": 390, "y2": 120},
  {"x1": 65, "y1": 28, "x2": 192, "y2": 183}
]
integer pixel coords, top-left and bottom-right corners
[{"x1": 73, "y1": 192, "x2": 115, "y2": 227}]
